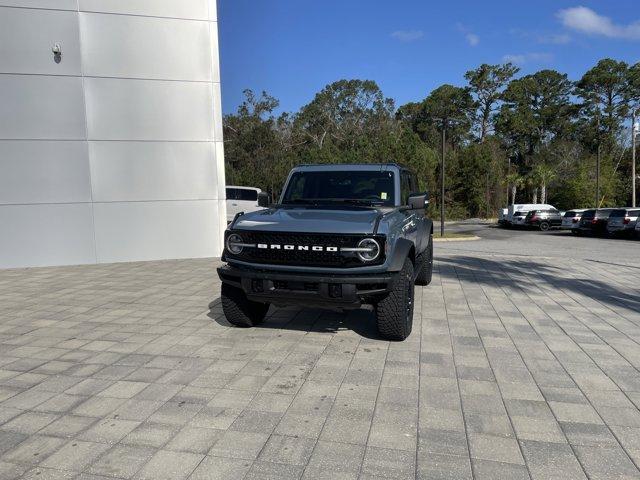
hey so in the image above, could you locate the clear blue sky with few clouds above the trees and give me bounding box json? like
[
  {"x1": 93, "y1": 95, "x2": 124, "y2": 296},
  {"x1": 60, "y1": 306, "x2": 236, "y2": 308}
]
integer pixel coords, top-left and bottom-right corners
[{"x1": 218, "y1": 0, "x2": 640, "y2": 113}]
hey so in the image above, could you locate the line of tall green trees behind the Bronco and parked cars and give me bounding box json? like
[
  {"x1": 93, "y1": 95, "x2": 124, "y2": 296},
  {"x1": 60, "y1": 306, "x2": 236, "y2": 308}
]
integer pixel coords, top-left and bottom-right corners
[{"x1": 224, "y1": 58, "x2": 640, "y2": 218}]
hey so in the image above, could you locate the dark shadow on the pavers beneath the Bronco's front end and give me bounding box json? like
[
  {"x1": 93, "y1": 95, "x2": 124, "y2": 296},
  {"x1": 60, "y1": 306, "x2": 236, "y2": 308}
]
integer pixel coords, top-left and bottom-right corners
[{"x1": 207, "y1": 299, "x2": 382, "y2": 340}]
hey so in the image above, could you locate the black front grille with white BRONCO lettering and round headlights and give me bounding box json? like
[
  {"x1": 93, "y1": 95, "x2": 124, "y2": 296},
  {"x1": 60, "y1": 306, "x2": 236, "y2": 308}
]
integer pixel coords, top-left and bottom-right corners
[{"x1": 225, "y1": 230, "x2": 384, "y2": 268}]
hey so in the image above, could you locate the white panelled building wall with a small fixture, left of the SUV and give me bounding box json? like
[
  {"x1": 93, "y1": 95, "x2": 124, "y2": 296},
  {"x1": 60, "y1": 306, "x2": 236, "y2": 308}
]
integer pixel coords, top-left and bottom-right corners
[{"x1": 0, "y1": 0, "x2": 226, "y2": 268}]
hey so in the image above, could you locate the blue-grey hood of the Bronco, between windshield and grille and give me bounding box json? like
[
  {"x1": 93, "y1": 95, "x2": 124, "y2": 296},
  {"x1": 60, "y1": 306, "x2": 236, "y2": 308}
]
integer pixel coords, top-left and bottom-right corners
[{"x1": 233, "y1": 207, "x2": 380, "y2": 234}]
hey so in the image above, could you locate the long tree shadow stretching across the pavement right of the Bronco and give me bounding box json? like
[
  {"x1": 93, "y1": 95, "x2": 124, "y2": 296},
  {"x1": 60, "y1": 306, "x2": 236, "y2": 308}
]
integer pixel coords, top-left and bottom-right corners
[{"x1": 437, "y1": 256, "x2": 640, "y2": 312}]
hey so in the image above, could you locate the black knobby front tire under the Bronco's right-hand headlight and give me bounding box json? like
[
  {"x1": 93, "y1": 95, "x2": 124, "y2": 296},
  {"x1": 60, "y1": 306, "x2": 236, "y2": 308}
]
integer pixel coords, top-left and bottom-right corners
[{"x1": 375, "y1": 258, "x2": 415, "y2": 340}]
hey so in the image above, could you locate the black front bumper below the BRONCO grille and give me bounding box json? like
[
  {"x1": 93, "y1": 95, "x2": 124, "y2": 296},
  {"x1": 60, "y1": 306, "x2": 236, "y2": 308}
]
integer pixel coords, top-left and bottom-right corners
[{"x1": 218, "y1": 265, "x2": 398, "y2": 310}]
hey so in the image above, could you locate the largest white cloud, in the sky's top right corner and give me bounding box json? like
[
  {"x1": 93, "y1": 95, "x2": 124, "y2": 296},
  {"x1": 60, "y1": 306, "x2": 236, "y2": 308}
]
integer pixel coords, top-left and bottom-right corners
[{"x1": 556, "y1": 6, "x2": 640, "y2": 40}]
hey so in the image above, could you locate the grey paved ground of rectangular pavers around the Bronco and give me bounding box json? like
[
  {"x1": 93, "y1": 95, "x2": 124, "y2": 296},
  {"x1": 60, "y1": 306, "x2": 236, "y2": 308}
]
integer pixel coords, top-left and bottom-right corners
[{"x1": 0, "y1": 226, "x2": 640, "y2": 480}]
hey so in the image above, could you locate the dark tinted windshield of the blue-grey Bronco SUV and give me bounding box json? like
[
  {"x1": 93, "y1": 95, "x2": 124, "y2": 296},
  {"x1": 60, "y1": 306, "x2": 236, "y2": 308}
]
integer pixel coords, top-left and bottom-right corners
[{"x1": 282, "y1": 170, "x2": 395, "y2": 206}]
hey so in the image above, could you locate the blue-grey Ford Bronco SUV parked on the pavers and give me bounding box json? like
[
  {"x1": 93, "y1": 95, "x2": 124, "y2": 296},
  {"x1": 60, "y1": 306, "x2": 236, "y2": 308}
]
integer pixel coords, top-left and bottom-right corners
[{"x1": 218, "y1": 164, "x2": 433, "y2": 340}]
